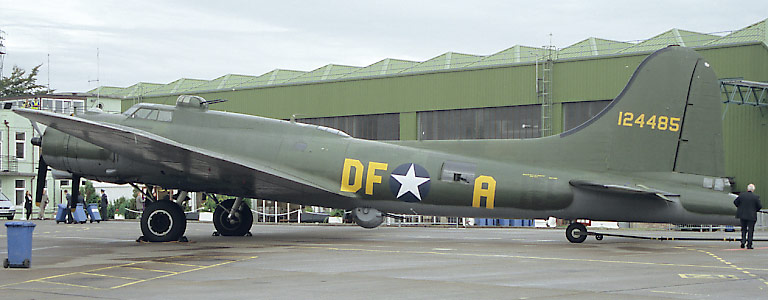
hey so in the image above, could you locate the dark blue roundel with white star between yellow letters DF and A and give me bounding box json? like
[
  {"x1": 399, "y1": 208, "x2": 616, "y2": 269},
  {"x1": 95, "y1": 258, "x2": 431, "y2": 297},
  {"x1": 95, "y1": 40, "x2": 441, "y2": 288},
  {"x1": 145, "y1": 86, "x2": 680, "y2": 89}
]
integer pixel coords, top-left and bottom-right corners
[{"x1": 389, "y1": 163, "x2": 430, "y2": 202}]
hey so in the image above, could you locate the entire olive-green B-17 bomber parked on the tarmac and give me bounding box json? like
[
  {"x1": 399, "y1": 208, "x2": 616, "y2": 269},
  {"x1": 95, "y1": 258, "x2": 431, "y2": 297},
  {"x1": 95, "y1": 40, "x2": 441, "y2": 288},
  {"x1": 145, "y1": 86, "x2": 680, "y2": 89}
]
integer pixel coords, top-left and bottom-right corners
[{"x1": 14, "y1": 46, "x2": 737, "y2": 243}]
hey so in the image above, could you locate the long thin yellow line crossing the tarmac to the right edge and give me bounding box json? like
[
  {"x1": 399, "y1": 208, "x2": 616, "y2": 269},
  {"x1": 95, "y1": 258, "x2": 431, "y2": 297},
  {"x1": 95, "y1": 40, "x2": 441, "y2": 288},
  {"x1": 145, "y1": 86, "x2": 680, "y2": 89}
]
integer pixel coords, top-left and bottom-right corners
[{"x1": 294, "y1": 246, "x2": 768, "y2": 271}]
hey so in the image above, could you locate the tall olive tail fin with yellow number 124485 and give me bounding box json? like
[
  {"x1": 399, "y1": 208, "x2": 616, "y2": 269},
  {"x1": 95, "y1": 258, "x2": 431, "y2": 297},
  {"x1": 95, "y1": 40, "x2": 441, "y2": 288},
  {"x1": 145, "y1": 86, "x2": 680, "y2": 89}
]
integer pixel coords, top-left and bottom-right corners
[{"x1": 560, "y1": 46, "x2": 725, "y2": 177}]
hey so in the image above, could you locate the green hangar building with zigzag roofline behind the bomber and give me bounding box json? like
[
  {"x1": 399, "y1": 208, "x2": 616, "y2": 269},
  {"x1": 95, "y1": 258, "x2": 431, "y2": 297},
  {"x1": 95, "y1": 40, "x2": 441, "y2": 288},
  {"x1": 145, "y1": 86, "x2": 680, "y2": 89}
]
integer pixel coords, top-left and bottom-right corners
[{"x1": 89, "y1": 19, "x2": 768, "y2": 196}]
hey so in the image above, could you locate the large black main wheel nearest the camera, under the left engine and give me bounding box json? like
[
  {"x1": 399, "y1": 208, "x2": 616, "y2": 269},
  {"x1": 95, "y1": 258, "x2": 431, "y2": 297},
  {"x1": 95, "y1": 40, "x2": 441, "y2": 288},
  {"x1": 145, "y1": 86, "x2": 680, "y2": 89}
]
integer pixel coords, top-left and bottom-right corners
[{"x1": 141, "y1": 201, "x2": 187, "y2": 242}]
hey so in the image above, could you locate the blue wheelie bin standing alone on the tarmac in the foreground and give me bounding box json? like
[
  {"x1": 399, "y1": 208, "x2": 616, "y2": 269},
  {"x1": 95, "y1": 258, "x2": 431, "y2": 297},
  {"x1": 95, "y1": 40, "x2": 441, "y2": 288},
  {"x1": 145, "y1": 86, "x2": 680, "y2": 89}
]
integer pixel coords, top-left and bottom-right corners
[{"x1": 3, "y1": 222, "x2": 36, "y2": 268}]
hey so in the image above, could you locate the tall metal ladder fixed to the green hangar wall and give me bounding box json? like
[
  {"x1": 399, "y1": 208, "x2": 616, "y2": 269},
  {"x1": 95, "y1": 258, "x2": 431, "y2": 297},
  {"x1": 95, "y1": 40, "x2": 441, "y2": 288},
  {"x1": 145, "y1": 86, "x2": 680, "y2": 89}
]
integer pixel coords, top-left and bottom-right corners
[{"x1": 536, "y1": 45, "x2": 556, "y2": 137}]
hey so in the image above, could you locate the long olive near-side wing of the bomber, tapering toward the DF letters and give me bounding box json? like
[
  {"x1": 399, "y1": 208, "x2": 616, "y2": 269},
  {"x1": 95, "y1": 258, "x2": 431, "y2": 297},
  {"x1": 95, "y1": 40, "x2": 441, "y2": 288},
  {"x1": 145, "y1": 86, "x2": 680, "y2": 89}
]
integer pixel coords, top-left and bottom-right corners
[{"x1": 13, "y1": 108, "x2": 339, "y2": 197}]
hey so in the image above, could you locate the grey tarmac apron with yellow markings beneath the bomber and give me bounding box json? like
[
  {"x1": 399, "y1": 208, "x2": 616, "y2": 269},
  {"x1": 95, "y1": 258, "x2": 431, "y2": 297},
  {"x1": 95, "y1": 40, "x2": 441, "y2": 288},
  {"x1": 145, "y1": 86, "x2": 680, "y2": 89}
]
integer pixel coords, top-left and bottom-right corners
[{"x1": 0, "y1": 220, "x2": 768, "y2": 300}]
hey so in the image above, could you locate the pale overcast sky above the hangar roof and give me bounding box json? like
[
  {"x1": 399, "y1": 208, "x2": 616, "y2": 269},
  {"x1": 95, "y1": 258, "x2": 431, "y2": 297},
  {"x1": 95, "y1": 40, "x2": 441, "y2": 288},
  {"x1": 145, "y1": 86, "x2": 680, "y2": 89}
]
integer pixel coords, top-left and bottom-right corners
[{"x1": 0, "y1": 0, "x2": 768, "y2": 92}]
